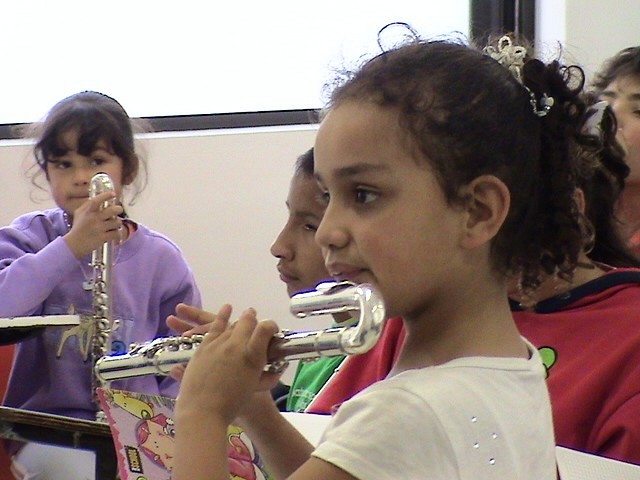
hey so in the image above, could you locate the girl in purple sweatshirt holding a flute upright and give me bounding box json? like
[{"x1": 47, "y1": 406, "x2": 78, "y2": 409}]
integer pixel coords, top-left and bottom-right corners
[{"x1": 0, "y1": 92, "x2": 201, "y2": 479}]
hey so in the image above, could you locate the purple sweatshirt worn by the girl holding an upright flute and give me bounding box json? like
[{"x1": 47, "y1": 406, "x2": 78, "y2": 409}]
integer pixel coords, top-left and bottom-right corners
[{"x1": 0, "y1": 208, "x2": 201, "y2": 420}]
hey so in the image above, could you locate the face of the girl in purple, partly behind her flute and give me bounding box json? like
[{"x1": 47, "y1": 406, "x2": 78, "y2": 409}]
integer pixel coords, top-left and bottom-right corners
[{"x1": 47, "y1": 130, "x2": 123, "y2": 216}]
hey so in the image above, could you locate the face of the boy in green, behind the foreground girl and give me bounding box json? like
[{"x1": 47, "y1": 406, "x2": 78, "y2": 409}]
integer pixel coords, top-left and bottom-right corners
[{"x1": 271, "y1": 174, "x2": 329, "y2": 296}]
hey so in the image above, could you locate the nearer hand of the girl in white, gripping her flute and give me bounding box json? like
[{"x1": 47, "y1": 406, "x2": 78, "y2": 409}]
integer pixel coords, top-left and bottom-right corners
[{"x1": 176, "y1": 305, "x2": 279, "y2": 424}]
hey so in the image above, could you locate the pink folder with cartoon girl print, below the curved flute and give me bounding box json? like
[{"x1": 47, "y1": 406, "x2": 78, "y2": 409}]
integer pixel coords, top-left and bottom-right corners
[{"x1": 98, "y1": 388, "x2": 272, "y2": 480}]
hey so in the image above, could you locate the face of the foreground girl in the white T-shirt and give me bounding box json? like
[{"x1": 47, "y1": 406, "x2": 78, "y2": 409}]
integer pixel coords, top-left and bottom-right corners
[{"x1": 315, "y1": 102, "x2": 465, "y2": 317}]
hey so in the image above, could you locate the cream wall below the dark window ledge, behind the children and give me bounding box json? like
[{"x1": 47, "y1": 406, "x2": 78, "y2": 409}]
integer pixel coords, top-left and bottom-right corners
[{"x1": 0, "y1": 126, "x2": 328, "y2": 379}]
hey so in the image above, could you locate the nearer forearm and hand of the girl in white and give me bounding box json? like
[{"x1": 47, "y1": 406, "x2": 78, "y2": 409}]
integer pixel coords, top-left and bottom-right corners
[{"x1": 173, "y1": 306, "x2": 278, "y2": 480}]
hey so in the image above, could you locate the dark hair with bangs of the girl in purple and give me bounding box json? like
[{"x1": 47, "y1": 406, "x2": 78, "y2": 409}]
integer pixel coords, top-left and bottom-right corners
[{"x1": 29, "y1": 91, "x2": 146, "y2": 201}]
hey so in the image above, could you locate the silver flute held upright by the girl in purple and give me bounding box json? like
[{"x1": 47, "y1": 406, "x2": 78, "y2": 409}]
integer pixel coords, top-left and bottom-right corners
[{"x1": 89, "y1": 173, "x2": 115, "y2": 421}]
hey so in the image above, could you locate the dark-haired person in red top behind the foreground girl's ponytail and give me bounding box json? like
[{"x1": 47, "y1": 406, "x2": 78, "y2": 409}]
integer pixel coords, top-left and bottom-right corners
[{"x1": 512, "y1": 104, "x2": 640, "y2": 464}]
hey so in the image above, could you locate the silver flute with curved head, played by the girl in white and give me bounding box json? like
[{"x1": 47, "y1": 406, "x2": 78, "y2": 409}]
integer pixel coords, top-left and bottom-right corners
[{"x1": 95, "y1": 282, "x2": 386, "y2": 382}]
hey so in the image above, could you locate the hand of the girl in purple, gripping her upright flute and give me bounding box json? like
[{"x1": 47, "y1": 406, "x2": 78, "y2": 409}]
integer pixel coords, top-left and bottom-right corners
[{"x1": 64, "y1": 192, "x2": 123, "y2": 259}]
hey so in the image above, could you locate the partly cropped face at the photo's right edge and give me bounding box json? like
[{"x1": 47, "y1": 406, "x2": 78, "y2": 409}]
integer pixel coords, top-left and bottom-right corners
[{"x1": 601, "y1": 76, "x2": 640, "y2": 184}]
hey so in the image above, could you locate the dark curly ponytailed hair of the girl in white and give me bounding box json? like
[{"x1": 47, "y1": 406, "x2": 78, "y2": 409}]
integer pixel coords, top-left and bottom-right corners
[{"x1": 328, "y1": 34, "x2": 586, "y2": 291}]
